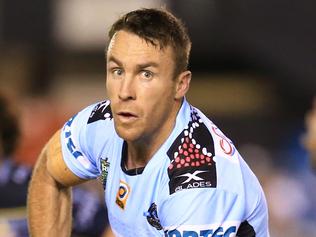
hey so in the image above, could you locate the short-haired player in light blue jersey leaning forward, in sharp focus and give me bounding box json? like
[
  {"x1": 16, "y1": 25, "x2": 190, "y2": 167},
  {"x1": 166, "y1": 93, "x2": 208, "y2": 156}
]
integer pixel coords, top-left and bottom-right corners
[{"x1": 28, "y1": 9, "x2": 269, "y2": 237}]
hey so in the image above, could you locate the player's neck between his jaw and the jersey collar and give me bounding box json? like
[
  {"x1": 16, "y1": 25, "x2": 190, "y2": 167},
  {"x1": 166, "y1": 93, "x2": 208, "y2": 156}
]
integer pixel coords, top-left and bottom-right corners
[{"x1": 126, "y1": 99, "x2": 182, "y2": 169}]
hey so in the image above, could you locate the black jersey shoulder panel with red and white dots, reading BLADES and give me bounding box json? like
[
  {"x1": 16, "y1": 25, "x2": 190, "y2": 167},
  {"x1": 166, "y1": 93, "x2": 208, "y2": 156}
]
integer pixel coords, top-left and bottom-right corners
[{"x1": 167, "y1": 107, "x2": 217, "y2": 194}]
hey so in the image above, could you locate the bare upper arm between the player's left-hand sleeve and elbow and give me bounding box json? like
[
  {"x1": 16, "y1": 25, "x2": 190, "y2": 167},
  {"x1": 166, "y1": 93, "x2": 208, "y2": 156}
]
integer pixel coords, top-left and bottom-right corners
[{"x1": 44, "y1": 130, "x2": 85, "y2": 186}]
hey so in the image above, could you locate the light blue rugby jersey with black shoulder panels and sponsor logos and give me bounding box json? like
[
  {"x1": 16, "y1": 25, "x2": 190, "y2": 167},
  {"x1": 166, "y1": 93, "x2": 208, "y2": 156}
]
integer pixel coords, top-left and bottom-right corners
[{"x1": 61, "y1": 100, "x2": 269, "y2": 237}]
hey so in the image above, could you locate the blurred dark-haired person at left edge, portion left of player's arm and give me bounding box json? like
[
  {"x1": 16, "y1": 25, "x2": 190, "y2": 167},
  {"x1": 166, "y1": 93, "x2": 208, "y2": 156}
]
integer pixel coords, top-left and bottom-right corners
[{"x1": 0, "y1": 93, "x2": 31, "y2": 237}]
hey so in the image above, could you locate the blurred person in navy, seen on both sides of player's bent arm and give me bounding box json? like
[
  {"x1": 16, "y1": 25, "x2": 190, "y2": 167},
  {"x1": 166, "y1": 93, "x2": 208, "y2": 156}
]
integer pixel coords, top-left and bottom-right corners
[{"x1": 0, "y1": 93, "x2": 108, "y2": 237}]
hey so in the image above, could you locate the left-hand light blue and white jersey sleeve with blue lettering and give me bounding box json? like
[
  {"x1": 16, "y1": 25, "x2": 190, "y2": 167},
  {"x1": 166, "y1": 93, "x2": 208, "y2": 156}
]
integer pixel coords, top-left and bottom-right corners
[{"x1": 60, "y1": 105, "x2": 99, "y2": 179}]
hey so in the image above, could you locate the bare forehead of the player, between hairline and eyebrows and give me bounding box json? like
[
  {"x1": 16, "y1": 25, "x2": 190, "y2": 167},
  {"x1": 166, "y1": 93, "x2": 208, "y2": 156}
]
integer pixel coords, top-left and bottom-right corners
[{"x1": 107, "y1": 31, "x2": 173, "y2": 63}]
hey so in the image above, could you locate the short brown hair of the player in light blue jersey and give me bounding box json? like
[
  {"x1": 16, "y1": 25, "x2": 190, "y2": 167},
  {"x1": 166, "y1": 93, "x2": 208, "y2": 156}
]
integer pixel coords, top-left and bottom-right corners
[{"x1": 109, "y1": 8, "x2": 191, "y2": 75}]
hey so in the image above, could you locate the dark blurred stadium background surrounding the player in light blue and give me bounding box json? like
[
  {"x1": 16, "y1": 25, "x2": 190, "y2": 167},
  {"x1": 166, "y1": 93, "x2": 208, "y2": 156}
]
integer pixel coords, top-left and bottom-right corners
[{"x1": 0, "y1": 0, "x2": 316, "y2": 237}]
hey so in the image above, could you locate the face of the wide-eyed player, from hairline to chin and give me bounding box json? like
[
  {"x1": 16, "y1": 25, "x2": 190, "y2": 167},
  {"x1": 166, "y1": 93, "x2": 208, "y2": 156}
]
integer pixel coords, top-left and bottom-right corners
[{"x1": 106, "y1": 31, "x2": 179, "y2": 142}]
